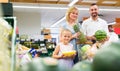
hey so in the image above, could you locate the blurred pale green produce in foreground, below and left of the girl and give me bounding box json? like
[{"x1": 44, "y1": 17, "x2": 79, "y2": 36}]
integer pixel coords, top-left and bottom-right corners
[{"x1": 19, "y1": 57, "x2": 67, "y2": 71}]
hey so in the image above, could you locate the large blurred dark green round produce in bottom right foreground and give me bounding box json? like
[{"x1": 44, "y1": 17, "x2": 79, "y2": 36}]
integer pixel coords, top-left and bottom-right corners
[{"x1": 92, "y1": 41, "x2": 120, "y2": 71}]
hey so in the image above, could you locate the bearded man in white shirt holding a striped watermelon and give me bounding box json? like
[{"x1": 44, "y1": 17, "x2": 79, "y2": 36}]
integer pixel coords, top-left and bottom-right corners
[{"x1": 82, "y1": 3, "x2": 109, "y2": 43}]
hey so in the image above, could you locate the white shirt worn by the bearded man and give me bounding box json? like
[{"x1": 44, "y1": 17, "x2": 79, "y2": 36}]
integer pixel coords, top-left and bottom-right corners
[{"x1": 82, "y1": 17, "x2": 109, "y2": 36}]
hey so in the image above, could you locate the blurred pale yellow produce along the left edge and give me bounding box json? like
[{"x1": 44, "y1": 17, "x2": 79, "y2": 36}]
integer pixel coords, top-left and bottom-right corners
[{"x1": 0, "y1": 18, "x2": 12, "y2": 71}]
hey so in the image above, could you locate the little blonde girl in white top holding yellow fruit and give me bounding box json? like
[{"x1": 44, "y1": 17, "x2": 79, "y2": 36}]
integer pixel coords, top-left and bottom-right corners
[{"x1": 52, "y1": 29, "x2": 76, "y2": 69}]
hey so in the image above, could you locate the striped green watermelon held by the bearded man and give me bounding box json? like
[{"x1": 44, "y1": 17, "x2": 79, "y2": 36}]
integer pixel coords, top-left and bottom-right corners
[{"x1": 95, "y1": 30, "x2": 107, "y2": 41}]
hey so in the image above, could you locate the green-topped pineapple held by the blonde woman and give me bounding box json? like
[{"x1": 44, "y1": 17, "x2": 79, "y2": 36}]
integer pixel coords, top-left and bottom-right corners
[{"x1": 73, "y1": 24, "x2": 87, "y2": 44}]
